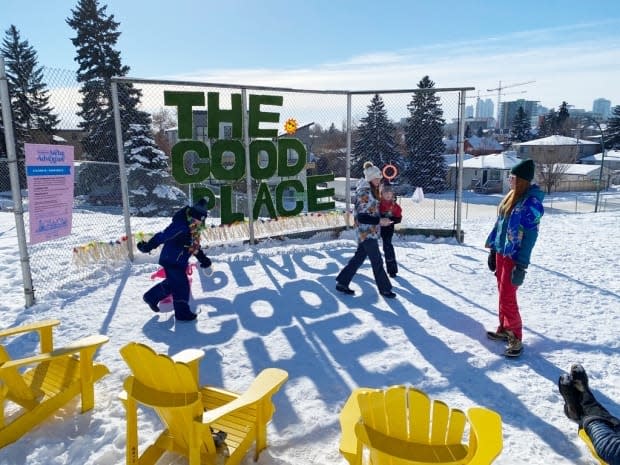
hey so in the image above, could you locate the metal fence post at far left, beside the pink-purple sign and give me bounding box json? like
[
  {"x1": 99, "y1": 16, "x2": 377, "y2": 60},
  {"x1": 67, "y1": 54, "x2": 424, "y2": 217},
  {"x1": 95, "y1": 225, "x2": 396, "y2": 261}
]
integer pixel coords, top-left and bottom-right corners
[{"x1": 0, "y1": 55, "x2": 34, "y2": 307}]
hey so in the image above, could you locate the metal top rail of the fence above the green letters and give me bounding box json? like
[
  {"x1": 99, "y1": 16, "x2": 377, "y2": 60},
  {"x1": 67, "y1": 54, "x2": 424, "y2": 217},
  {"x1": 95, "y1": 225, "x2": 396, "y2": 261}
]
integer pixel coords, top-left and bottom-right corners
[{"x1": 112, "y1": 76, "x2": 476, "y2": 95}]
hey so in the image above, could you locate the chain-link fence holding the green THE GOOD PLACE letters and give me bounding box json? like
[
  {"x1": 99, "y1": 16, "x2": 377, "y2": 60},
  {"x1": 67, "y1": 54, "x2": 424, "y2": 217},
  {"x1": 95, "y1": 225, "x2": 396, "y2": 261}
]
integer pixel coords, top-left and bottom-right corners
[{"x1": 0, "y1": 60, "x2": 474, "y2": 297}]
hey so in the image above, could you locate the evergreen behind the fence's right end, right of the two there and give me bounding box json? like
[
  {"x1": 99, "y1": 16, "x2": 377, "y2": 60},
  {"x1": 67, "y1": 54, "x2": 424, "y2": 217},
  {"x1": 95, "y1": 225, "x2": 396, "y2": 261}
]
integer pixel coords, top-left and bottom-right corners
[{"x1": 405, "y1": 76, "x2": 447, "y2": 192}]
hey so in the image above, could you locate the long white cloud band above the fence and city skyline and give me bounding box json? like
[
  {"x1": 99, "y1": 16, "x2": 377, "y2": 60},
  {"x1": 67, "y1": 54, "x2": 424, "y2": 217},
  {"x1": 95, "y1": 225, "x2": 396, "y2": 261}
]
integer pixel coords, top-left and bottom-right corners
[{"x1": 160, "y1": 21, "x2": 620, "y2": 109}]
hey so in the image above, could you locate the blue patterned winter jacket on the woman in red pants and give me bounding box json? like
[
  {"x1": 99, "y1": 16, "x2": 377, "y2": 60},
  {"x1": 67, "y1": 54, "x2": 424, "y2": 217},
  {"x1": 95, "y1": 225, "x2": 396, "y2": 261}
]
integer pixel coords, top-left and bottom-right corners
[{"x1": 485, "y1": 184, "x2": 545, "y2": 266}]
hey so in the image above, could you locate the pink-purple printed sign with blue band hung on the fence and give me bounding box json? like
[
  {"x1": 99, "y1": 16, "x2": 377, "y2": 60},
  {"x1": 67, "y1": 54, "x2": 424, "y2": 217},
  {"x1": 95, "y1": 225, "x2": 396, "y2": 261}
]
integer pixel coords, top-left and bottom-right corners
[{"x1": 24, "y1": 144, "x2": 74, "y2": 244}]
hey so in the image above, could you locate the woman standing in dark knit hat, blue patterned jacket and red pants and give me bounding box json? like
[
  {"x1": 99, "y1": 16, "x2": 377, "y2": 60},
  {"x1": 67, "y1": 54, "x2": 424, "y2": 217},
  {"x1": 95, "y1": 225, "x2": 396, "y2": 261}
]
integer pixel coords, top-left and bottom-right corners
[{"x1": 485, "y1": 160, "x2": 545, "y2": 357}]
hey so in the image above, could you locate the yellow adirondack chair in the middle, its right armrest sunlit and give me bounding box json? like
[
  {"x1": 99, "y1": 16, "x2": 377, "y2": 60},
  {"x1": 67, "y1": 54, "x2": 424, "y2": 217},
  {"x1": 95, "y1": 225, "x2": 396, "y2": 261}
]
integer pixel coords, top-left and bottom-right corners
[{"x1": 121, "y1": 342, "x2": 288, "y2": 465}]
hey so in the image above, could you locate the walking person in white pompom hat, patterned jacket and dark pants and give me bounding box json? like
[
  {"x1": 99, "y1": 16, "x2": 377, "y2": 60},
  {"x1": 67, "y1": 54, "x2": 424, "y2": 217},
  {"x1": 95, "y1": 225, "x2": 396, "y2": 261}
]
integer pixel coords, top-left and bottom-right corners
[{"x1": 336, "y1": 161, "x2": 396, "y2": 298}]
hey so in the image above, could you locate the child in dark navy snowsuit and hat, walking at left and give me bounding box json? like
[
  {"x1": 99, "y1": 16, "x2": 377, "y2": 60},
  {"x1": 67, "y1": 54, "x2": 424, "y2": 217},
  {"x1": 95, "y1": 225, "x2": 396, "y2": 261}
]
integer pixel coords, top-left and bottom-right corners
[{"x1": 136, "y1": 199, "x2": 211, "y2": 321}]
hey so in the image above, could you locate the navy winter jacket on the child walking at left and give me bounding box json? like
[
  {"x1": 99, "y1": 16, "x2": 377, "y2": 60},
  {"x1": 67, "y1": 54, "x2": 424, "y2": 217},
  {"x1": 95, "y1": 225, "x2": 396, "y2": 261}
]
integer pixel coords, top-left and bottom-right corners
[{"x1": 143, "y1": 207, "x2": 209, "y2": 269}]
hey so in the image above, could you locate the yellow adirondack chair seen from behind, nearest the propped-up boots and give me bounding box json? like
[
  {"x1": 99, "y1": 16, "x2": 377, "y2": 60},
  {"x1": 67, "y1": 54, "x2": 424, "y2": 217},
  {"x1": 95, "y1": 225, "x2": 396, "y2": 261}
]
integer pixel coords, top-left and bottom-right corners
[{"x1": 340, "y1": 386, "x2": 502, "y2": 465}]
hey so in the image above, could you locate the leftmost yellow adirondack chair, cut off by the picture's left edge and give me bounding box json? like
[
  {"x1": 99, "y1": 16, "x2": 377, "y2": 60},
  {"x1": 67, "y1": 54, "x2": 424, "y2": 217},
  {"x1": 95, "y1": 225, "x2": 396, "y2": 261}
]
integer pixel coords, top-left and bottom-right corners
[{"x1": 0, "y1": 320, "x2": 109, "y2": 447}]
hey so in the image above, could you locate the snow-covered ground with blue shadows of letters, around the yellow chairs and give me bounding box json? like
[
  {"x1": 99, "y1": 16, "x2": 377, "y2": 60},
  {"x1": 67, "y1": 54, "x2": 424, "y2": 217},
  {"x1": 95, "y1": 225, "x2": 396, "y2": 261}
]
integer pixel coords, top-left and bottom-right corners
[{"x1": 0, "y1": 208, "x2": 620, "y2": 465}]
